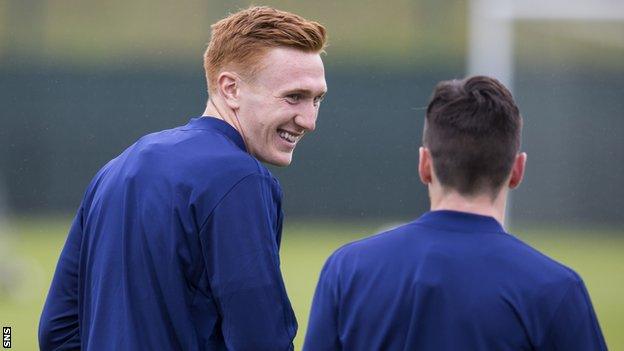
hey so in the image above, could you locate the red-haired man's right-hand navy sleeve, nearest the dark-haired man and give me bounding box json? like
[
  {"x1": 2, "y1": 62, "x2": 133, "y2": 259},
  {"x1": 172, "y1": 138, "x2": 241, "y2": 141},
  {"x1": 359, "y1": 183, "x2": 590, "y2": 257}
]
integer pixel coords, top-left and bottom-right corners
[{"x1": 200, "y1": 174, "x2": 297, "y2": 351}]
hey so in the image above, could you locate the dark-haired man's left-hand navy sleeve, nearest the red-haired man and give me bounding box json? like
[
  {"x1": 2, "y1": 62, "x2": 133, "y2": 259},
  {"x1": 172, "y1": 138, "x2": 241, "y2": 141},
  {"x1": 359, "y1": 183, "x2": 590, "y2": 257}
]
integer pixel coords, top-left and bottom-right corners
[{"x1": 303, "y1": 256, "x2": 342, "y2": 351}]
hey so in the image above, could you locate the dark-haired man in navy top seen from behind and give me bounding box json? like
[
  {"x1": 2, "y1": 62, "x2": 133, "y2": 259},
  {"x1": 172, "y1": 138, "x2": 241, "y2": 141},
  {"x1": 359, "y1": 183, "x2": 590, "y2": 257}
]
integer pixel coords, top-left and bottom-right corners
[{"x1": 304, "y1": 77, "x2": 606, "y2": 351}]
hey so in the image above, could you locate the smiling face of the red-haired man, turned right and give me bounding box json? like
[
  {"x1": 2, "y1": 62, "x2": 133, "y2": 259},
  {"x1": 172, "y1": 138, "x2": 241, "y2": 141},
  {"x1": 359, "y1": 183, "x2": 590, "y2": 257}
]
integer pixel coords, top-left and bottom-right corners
[{"x1": 238, "y1": 48, "x2": 327, "y2": 166}]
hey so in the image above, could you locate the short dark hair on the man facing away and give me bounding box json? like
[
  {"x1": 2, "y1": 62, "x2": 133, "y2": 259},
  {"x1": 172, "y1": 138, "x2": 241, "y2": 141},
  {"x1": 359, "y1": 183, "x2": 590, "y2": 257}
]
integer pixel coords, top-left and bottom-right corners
[{"x1": 423, "y1": 76, "x2": 522, "y2": 196}]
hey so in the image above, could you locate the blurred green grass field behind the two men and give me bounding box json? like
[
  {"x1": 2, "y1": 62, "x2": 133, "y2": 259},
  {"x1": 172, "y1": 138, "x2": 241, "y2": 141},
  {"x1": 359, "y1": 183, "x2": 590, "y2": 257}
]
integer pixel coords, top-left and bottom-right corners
[{"x1": 0, "y1": 218, "x2": 624, "y2": 350}]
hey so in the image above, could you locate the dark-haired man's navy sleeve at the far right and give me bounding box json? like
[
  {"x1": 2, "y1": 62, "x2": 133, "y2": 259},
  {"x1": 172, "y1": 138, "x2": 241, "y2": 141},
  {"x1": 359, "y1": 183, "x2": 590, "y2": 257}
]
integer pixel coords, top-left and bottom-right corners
[{"x1": 538, "y1": 274, "x2": 607, "y2": 351}]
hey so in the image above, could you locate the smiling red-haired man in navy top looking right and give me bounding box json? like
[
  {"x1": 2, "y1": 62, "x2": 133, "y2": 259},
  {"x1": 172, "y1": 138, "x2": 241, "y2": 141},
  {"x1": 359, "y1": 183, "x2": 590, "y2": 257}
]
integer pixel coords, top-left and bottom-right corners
[{"x1": 39, "y1": 7, "x2": 327, "y2": 351}]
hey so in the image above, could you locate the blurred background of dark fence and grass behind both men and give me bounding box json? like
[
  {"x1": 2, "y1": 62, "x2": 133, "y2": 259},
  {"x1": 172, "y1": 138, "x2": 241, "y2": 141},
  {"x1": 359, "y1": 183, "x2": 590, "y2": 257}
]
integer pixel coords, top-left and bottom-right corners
[{"x1": 0, "y1": 0, "x2": 624, "y2": 350}]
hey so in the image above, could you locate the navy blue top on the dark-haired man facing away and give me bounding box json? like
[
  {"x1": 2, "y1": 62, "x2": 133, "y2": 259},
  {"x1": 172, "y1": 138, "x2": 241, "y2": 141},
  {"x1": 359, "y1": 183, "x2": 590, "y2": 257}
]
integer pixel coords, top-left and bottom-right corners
[{"x1": 304, "y1": 211, "x2": 606, "y2": 351}]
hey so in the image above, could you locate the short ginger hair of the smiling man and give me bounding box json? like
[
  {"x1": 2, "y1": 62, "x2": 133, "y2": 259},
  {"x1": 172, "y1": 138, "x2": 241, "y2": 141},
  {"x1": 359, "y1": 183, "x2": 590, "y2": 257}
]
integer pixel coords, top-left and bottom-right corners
[{"x1": 204, "y1": 6, "x2": 327, "y2": 92}]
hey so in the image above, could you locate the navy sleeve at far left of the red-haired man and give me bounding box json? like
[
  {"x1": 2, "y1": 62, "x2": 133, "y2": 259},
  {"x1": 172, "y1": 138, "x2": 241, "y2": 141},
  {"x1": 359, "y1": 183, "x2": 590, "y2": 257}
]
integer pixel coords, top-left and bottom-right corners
[{"x1": 39, "y1": 207, "x2": 83, "y2": 351}]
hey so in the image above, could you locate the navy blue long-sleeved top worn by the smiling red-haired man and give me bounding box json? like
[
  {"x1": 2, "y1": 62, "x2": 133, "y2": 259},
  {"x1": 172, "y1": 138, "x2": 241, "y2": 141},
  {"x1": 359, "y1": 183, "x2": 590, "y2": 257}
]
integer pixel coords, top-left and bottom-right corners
[{"x1": 39, "y1": 117, "x2": 297, "y2": 351}]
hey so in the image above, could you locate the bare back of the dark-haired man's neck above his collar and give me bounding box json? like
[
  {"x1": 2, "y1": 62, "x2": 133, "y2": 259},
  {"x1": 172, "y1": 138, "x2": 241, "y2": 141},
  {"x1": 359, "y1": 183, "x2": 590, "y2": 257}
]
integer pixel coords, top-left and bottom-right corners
[{"x1": 431, "y1": 191, "x2": 507, "y2": 226}]
